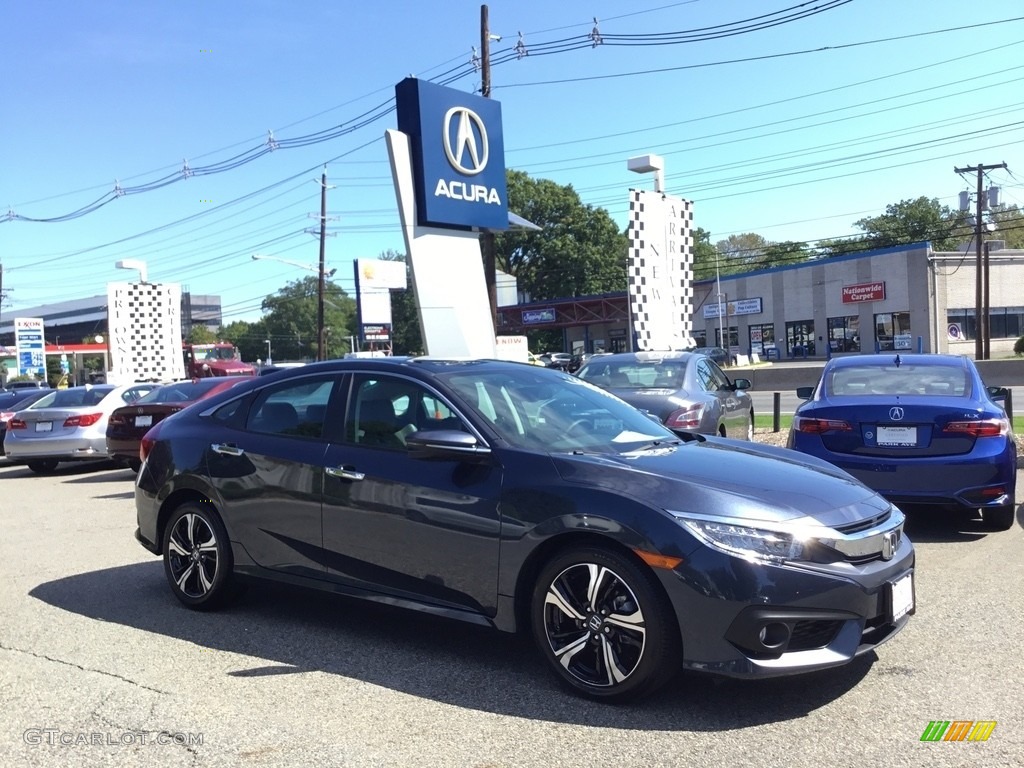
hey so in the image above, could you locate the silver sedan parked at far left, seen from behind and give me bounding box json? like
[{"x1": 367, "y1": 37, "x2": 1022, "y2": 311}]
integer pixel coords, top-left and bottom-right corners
[{"x1": 3, "y1": 382, "x2": 159, "y2": 473}]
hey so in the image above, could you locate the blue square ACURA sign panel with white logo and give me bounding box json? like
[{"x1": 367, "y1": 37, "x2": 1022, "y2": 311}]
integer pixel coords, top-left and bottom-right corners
[{"x1": 394, "y1": 78, "x2": 509, "y2": 229}]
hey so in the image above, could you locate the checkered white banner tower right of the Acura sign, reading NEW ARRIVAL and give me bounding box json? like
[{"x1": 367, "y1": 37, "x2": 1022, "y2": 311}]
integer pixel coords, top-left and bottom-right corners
[{"x1": 627, "y1": 189, "x2": 696, "y2": 350}]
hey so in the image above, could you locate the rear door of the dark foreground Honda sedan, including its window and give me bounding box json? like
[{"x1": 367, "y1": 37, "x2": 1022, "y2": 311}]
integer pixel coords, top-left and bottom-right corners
[{"x1": 201, "y1": 374, "x2": 341, "y2": 579}]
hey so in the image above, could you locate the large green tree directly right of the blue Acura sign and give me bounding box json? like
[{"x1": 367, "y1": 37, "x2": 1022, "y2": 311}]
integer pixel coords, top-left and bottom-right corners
[{"x1": 495, "y1": 170, "x2": 629, "y2": 301}]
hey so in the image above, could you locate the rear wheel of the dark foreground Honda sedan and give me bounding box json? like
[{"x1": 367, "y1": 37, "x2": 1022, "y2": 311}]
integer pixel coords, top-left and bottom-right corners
[{"x1": 163, "y1": 502, "x2": 233, "y2": 610}]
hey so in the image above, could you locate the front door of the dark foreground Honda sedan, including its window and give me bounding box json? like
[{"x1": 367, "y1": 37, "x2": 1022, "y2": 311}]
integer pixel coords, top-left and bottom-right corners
[{"x1": 324, "y1": 373, "x2": 502, "y2": 614}]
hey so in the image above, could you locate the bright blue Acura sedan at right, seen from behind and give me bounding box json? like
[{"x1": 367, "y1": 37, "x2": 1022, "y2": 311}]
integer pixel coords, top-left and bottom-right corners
[{"x1": 788, "y1": 353, "x2": 1017, "y2": 530}]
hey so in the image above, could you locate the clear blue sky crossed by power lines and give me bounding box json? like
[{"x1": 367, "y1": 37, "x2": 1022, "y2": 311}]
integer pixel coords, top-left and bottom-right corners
[{"x1": 0, "y1": 0, "x2": 1024, "y2": 322}]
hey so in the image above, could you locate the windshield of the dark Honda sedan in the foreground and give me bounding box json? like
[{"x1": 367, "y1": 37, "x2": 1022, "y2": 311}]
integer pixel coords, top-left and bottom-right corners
[{"x1": 446, "y1": 366, "x2": 679, "y2": 454}]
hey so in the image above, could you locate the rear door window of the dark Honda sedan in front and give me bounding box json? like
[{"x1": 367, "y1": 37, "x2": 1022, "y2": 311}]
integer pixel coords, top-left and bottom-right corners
[{"x1": 246, "y1": 377, "x2": 335, "y2": 437}]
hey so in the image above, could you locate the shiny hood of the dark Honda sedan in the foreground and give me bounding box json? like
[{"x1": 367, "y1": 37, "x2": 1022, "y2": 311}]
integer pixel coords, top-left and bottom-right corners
[{"x1": 553, "y1": 438, "x2": 890, "y2": 527}]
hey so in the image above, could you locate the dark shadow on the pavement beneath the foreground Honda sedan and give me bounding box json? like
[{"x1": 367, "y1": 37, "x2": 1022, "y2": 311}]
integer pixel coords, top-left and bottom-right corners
[{"x1": 31, "y1": 560, "x2": 877, "y2": 731}]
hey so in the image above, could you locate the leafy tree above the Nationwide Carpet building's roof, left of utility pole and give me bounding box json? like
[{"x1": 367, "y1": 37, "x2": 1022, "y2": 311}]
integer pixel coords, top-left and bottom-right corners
[{"x1": 854, "y1": 197, "x2": 970, "y2": 251}]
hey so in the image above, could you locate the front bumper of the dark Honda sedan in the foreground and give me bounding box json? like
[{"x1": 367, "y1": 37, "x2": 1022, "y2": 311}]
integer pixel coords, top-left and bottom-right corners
[{"x1": 657, "y1": 537, "x2": 914, "y2": 678}]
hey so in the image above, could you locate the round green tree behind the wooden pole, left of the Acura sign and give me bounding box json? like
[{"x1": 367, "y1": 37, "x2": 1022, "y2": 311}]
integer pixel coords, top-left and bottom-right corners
[{"x1": 262, "y1": 275, "x2": 355, "y2": 360}]
